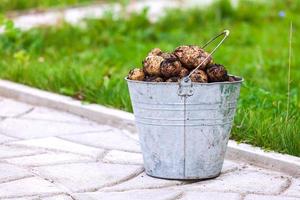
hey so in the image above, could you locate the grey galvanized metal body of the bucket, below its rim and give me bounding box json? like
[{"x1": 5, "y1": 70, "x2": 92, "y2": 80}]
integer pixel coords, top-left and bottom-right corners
[{"x1": 127, "y1": 79, "x2": 242, "y2": 179}]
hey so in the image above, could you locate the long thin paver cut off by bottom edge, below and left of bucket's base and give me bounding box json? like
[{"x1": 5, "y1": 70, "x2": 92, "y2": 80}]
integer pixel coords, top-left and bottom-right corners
[{"x1": 74, "y1": 190, "x2": 181, "y2": 200}]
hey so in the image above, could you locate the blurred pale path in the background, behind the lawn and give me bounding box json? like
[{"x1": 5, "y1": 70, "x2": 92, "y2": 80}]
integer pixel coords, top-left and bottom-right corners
[{"x1": 0, "y1": 0, "x2": 232, "y2": 33}]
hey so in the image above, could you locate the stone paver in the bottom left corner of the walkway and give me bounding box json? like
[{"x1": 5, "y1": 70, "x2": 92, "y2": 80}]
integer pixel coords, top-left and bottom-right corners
[{"x1": 0, "y1": 177, "x2": 63, "y2": 198}]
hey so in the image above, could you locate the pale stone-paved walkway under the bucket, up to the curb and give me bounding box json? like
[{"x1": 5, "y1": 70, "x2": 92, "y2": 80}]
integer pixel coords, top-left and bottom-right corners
[{"x1": 0, "y1": 97, "x2": 300, "y2": 200}]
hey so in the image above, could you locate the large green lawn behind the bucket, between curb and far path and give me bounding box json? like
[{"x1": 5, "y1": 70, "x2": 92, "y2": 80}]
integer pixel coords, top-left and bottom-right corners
[{"x1": 0, "y1": 0, "x2": 300, "y2": 156}]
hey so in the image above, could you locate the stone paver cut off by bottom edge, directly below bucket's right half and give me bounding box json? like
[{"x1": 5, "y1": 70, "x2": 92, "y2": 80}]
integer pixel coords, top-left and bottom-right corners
[{"x1": 180, "y1": 192, "x2": 242, "y2": 200}]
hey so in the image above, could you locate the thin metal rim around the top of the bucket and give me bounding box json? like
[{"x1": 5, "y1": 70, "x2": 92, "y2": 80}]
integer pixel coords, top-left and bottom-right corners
[{"x1": 124, "y1": 74, "x2": 244, "y2": 85}]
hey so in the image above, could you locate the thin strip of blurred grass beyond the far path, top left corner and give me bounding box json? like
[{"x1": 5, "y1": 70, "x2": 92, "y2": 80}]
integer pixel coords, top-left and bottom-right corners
[{"x1": 0, "y1": 0, "x2": 95, "y2": 12}]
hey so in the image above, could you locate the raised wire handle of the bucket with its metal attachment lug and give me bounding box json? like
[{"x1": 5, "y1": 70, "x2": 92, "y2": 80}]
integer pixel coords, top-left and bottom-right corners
[{"x1": 177, "y1": 30, "x2": 230, "y2": 96}]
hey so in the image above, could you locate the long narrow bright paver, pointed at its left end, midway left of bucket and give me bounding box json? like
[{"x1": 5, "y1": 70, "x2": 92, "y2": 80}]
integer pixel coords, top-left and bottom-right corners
[{"x1": 10, "y1": 137, "x2": 104, "y2": 158}]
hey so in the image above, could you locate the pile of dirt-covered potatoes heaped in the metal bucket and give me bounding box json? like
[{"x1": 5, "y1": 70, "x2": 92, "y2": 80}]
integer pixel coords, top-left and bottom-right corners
[{"x1": 127, "y1": 45, "x2": 236, "y2": 83}]
